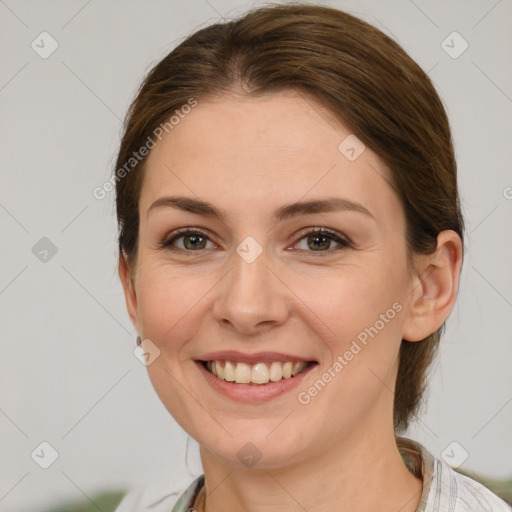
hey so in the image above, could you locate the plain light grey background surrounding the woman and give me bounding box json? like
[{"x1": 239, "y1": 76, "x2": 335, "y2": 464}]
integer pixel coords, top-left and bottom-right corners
[{"x1": 0, "y1": 0, "x2": 512, "y2": 512}]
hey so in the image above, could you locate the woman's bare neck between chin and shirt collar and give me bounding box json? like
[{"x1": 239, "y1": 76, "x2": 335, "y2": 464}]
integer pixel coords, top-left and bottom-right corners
[{"x1": 198, "y1": 422, "x2": 422, "y2": 512}]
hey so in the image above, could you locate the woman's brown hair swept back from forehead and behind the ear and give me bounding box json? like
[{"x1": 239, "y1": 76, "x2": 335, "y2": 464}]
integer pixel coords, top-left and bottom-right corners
[{"x1": 116, "y1": 4, "x2": 464, "y2": 432}]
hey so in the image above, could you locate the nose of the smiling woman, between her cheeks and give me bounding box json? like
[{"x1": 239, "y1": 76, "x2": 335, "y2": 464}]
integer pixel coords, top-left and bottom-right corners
[{"x1": 213, "y1": 242, "x2": 290, "y2": 334}]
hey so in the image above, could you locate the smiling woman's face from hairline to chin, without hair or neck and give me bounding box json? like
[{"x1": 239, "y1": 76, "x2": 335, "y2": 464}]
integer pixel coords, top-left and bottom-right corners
[{"x1": 125, "y1": 91, "x2": 424, "y2": 467}]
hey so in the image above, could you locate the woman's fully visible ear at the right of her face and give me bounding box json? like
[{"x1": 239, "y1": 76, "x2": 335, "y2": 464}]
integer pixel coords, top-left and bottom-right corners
[{"x1": 402, "y1": 230, "x2": 463, "y2": 341}]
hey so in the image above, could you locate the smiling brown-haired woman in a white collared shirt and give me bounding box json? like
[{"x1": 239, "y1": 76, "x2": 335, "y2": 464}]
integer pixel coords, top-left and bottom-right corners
[{"x1": 115, "y1": 5, "x2": 510, "y2": 512}]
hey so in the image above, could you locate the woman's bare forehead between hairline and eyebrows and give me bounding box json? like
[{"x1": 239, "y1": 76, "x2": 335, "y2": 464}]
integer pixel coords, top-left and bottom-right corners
[{"x1": 139, "y1": 91, "x2": 396, "y2": 226}]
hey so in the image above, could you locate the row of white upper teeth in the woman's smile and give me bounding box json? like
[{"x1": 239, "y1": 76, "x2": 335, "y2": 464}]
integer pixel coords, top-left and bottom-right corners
[{"x1": 206, "y1": 361, "x2": 307, "y2": 384}]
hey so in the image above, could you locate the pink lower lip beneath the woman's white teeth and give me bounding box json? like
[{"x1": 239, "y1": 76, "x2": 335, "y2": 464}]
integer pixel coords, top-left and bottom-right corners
[{"x1": 195, "y1": 361, "x2": 318, "y2": 403}]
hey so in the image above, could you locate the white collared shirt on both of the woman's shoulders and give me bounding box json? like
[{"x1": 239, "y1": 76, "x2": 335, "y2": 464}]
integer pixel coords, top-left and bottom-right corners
[{"x1": 115, "y1": 436, "x2": 512, "y2": 512}]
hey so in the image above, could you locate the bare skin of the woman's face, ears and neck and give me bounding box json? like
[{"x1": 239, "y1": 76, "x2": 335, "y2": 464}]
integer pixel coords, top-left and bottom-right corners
[{"x1": 119, "y1": 91, "x2": 462, "y2": 512}]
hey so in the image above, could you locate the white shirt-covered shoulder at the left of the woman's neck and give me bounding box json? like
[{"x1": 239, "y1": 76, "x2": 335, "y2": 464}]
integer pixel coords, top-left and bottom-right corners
[{"x1": 115, "y1": 475, "x2": 203, "y2": 512}]
